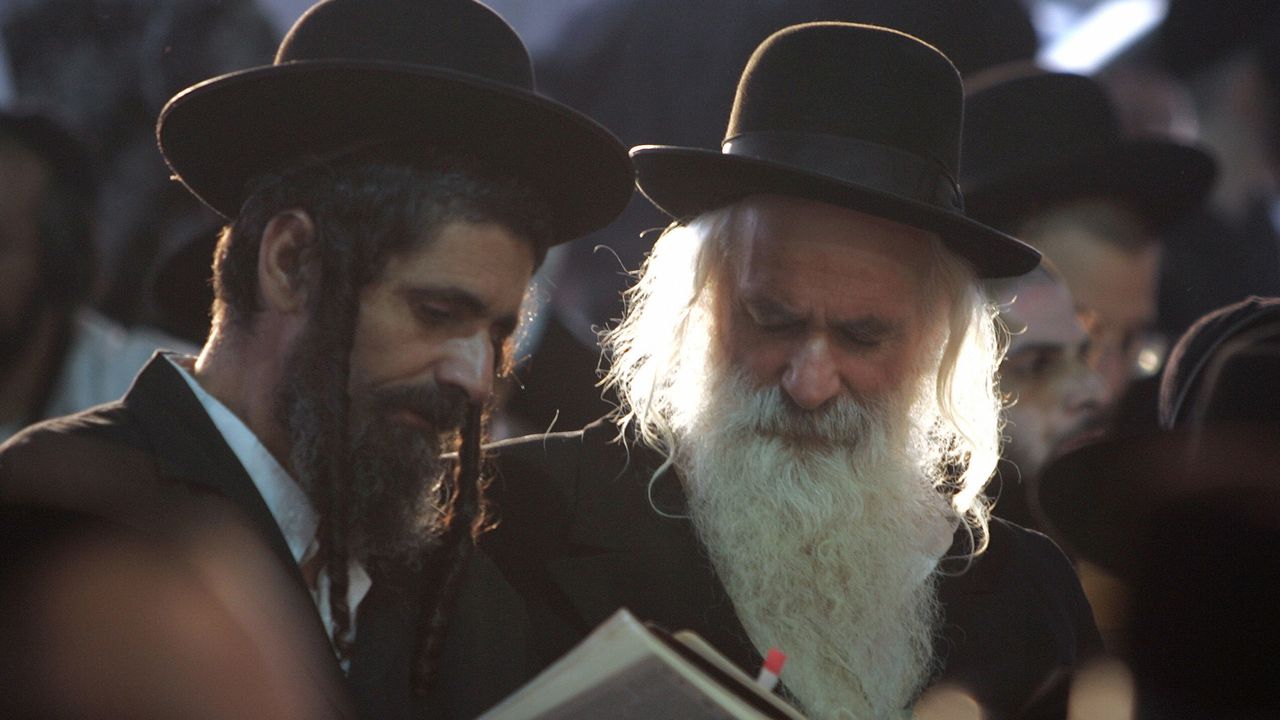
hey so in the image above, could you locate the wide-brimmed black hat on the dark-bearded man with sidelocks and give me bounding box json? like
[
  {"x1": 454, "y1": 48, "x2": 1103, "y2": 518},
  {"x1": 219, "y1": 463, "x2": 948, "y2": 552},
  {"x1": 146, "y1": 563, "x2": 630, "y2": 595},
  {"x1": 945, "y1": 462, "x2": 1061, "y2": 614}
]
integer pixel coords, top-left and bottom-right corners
[{"x1": 156, "y1": 0, "x2": 632, "y2": 241}]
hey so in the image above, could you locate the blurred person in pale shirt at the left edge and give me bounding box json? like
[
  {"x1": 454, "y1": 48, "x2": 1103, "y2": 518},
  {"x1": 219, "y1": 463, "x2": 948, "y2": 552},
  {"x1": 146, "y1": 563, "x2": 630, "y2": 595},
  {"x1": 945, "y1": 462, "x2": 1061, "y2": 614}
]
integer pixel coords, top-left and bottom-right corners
[{"x1": 0, "y1": 110, "x2": 193, "y2": 442}]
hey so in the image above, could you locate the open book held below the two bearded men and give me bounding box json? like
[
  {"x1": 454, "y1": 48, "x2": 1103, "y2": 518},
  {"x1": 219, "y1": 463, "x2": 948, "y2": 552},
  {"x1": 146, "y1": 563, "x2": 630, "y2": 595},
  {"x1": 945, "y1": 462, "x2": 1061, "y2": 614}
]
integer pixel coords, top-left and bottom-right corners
[{"x1": 480, "y1": 610, "x2": 804, "y2": 720}]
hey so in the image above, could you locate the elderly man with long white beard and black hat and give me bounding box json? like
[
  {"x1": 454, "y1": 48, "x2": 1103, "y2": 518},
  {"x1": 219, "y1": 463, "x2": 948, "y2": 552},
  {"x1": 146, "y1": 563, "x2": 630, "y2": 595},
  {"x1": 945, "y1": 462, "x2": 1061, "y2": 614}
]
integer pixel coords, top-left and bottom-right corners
[{"x1": 460, "y1": 23, "x2": 1098, "y2": 717}]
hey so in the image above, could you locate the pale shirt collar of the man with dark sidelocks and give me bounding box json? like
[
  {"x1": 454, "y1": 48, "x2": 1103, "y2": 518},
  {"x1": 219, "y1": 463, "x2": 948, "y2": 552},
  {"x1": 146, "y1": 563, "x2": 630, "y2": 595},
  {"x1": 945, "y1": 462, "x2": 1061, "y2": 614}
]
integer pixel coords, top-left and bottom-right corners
[{"x1": 165, "y1": 355, "x2": 371, "y2": 670}]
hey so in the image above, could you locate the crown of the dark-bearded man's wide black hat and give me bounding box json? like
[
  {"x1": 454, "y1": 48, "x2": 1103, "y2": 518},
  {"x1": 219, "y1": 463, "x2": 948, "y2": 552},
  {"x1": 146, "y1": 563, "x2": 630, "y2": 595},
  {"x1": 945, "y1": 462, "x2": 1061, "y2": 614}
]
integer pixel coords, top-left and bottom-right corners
[{"x1": 275, "y1": 0, "x2": 534, "y2": 91}]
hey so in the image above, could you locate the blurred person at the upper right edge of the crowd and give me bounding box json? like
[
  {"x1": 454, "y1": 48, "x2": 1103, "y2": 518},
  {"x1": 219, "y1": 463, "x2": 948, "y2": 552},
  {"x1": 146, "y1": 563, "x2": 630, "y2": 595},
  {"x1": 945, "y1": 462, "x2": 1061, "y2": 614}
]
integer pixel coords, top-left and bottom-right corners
[{"x1": 1149, "y1": 0, "x2": 1280, "y2": 337}]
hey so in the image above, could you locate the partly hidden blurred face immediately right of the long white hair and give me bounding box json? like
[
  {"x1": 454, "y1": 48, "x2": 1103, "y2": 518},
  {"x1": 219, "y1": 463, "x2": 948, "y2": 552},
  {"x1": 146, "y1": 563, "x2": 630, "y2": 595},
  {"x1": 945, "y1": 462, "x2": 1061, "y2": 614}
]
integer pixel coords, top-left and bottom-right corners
[{"x1": 1000, "y1": 275, "x2": 1110, "y2": 477}]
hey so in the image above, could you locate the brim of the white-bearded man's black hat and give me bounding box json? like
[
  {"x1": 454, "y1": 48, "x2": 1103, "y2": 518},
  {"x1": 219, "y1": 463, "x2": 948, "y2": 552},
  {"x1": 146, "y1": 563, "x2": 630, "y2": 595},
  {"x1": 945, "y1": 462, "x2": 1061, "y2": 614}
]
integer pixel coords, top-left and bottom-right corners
[{"x1": 631, "y1": 145, "x2": 1041, "y2": 278}]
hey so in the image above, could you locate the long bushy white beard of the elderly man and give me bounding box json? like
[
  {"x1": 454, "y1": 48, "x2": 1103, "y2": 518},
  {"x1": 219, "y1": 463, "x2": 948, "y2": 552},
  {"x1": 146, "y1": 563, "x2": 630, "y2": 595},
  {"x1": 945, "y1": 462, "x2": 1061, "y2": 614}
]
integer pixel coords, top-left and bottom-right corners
[{"x1": 676, "y1": 368, "x2": 956, "y2": 719}]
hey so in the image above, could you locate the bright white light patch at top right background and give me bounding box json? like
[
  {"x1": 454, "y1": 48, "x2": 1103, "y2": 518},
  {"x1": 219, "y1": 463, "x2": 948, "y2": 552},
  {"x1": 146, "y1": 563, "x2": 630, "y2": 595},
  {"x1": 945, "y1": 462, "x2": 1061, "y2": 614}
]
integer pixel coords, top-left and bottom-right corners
[{"x1": 1037, "y1": 0, "x2": 1169, "y2": 74}]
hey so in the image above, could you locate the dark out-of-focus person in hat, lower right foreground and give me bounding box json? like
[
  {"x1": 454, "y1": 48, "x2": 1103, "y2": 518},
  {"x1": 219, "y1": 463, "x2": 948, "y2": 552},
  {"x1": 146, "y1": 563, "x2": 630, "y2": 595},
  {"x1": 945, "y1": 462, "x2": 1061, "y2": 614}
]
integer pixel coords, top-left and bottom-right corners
[{"x1": 1038, "y1": 297, "x2": 1280, "y2": 720}]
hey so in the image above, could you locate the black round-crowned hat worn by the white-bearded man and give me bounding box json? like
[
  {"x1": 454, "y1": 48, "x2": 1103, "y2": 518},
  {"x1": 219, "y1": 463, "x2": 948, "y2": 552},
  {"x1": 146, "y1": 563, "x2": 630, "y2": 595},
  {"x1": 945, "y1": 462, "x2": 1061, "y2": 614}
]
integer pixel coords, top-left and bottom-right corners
[{"x1": 631, "y1": 22, "x2": 1039, "y2": 277}]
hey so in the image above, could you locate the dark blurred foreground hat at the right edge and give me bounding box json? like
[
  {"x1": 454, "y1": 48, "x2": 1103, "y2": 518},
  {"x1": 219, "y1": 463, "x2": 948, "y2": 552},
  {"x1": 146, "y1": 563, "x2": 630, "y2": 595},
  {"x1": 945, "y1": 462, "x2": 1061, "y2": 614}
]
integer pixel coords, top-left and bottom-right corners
[{"x1": 1037, "y1": 297, "x2": 1280, "y2": 577}]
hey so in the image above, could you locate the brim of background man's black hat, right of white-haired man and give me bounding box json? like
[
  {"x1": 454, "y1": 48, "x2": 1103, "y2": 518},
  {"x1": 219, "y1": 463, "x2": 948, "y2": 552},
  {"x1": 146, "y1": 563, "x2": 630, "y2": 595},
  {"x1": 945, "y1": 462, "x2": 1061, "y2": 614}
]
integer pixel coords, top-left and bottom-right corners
[{"x1": 964, "y1": 140, "x2": 1217, "y2": 229}]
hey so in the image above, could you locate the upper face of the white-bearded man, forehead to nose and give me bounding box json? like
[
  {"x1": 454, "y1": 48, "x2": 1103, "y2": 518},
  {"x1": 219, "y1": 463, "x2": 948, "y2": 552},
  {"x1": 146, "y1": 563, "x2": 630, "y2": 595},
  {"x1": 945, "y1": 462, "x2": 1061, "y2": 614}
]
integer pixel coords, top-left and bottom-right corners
[{"x1": 717, "y1": 197, "x2": 931, "y2": 410}]
